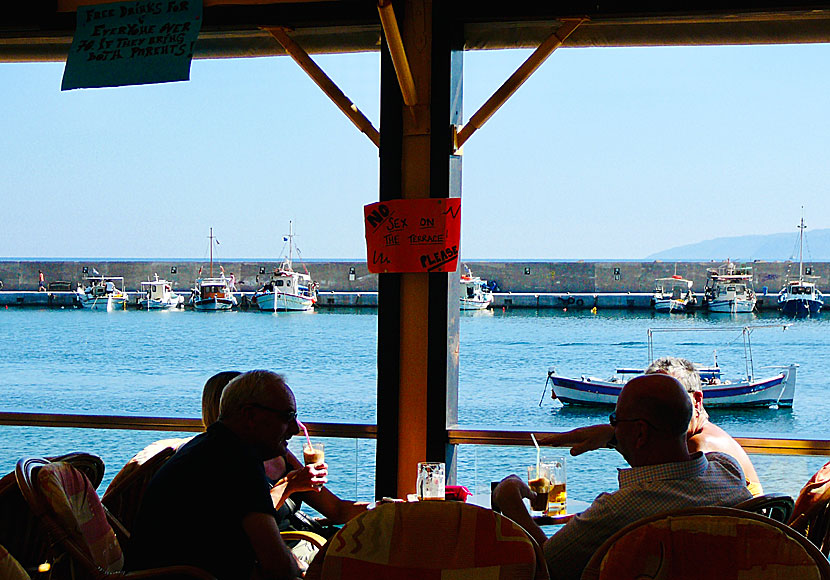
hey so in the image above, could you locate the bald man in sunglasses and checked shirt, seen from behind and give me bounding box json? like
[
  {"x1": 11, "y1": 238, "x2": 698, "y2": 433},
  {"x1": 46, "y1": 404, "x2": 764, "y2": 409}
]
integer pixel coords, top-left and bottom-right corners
[{"x1": 492, "y1": 374, "x2": 751, "y2": 580}]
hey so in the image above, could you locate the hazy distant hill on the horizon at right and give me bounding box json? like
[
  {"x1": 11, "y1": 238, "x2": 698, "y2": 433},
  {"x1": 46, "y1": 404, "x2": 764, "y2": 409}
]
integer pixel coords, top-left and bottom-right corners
[{"x1": 646, "y1": 229, "x2": 830, "y2": 262}]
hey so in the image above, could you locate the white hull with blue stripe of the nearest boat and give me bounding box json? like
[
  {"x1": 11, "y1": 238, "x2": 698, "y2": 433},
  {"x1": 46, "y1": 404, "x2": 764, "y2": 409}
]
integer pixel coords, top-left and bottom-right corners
[{"x1": 548, "y1": 365, "x2": 798, "y2": 408}]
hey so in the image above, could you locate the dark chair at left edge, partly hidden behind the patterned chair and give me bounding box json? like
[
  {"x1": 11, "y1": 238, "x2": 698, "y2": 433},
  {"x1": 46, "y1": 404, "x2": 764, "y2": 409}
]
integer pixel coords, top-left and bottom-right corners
[{"x1": 0, "y1": 453, "x2": 104, "y2": 577}]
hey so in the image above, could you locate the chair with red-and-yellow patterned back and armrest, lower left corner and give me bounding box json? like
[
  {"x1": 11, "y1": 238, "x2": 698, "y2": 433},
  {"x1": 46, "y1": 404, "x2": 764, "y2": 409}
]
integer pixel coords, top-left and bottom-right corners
[{"x1": 15, "y1": 458, "x2": 218, "y2": 580}]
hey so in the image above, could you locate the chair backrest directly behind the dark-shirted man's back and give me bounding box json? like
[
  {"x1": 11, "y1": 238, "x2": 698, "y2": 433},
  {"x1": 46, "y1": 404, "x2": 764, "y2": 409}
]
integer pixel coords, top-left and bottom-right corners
[{"x1": 101, "y1": 439, "x2": 182, "y2": 549}]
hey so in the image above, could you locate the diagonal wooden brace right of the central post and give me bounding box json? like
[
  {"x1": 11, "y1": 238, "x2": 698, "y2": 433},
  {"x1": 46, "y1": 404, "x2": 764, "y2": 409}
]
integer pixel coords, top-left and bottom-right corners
[{"x1": 453, "y1": 18, "x2": 586, "y2": 151}]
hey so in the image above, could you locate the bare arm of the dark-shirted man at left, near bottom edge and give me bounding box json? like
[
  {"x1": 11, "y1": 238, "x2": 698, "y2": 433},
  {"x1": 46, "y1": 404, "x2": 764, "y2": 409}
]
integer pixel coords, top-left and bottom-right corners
[{"x1": 242, "y1": 512, "x2": 302, "y2": 580}]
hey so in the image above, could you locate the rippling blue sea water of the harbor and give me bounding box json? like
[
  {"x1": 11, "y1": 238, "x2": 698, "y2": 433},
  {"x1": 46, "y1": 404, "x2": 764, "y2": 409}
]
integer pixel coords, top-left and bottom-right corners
[{"x1": 0, "y1": 308, "x2": 830, "y2": 512}]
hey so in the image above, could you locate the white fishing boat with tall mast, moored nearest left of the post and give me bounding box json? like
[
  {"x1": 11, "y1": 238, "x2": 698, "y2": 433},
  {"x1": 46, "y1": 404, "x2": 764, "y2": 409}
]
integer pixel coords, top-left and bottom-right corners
[{"x1": 253, "y1": 221, "x2": 318, "y2": 312}]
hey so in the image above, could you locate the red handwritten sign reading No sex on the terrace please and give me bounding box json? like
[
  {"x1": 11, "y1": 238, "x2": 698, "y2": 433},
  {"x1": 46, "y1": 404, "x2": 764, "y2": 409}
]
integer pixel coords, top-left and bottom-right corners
[{"x1": 363, "y1": 198, "x2": 461, "y2": 274}]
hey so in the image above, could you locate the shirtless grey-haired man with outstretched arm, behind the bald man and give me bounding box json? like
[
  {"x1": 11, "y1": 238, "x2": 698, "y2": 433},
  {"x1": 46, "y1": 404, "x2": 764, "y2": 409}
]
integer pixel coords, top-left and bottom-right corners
[{"x1": 539, "y1": 356, "x2": 764, "y2": 495}]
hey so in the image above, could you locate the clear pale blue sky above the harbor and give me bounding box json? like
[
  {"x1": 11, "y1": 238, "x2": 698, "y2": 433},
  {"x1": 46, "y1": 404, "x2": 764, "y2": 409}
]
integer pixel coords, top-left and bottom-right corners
[{"x1": 0, "y1": 45, "x2": 830, "y2": 260}]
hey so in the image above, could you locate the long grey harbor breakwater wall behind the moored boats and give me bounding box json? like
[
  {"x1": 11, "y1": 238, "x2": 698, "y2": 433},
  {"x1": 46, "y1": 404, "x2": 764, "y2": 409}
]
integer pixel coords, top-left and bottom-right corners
[{"x1": 0, "y1": 260, "x2": 830, "y2": 296}]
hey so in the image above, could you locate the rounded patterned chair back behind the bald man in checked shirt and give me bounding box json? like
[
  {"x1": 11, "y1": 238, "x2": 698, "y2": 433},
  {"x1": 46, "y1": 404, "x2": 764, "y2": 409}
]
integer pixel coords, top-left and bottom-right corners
[{"x1": 582, "y1": 507, "x2": 830, "y2": 580}]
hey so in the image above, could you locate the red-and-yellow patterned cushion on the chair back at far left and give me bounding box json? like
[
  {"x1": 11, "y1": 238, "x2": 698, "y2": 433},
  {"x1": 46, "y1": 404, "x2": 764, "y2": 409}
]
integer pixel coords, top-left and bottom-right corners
[{"x1": 37, "y1": 462, "x2": 124, "y2": 572}]
